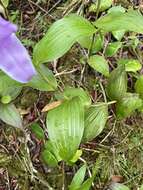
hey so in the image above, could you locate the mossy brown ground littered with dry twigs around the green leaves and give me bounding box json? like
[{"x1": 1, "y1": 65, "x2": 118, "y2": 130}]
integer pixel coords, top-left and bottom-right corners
[{"x1": 0, "y1": 0, "x2": 143, "y2": 190}]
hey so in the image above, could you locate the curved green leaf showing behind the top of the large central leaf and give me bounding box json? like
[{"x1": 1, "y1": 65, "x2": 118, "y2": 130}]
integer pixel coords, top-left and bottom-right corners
[{"x1": 63, "y1": 87, "x2": 91, "y2": 106}]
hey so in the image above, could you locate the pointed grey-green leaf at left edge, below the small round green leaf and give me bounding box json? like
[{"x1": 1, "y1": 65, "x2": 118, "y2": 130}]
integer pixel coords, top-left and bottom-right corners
[{"x1": 0, "y1": 104, "x2": 22, "y2": 128}]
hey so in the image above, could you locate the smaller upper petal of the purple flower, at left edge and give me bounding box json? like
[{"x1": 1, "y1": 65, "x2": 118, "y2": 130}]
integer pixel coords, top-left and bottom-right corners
[{"x1": 0, "y1": 16, "x2": 17, "y2": 40}]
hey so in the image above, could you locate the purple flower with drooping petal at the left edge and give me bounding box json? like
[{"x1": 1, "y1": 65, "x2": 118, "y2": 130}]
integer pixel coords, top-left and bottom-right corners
[{"x1": 0, "y1": 17, "x2": 36, "y2": 83}]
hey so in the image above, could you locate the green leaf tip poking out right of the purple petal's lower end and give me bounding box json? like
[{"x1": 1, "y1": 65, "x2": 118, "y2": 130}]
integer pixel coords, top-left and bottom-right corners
[{"x1": 26, "y1": 64, "x2": 57, "y2": 91}]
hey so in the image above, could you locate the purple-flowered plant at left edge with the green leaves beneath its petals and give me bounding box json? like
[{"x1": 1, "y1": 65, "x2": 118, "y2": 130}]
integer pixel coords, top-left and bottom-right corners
[{"x1": 0, "y1": 16, "x2": 57, "y2": 128}]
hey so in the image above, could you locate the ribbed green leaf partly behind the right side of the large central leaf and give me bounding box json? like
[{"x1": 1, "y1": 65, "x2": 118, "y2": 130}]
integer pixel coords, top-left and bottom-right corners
[{"x1": 82, "y1": 103, "x2": 108, "y2": 142}]
